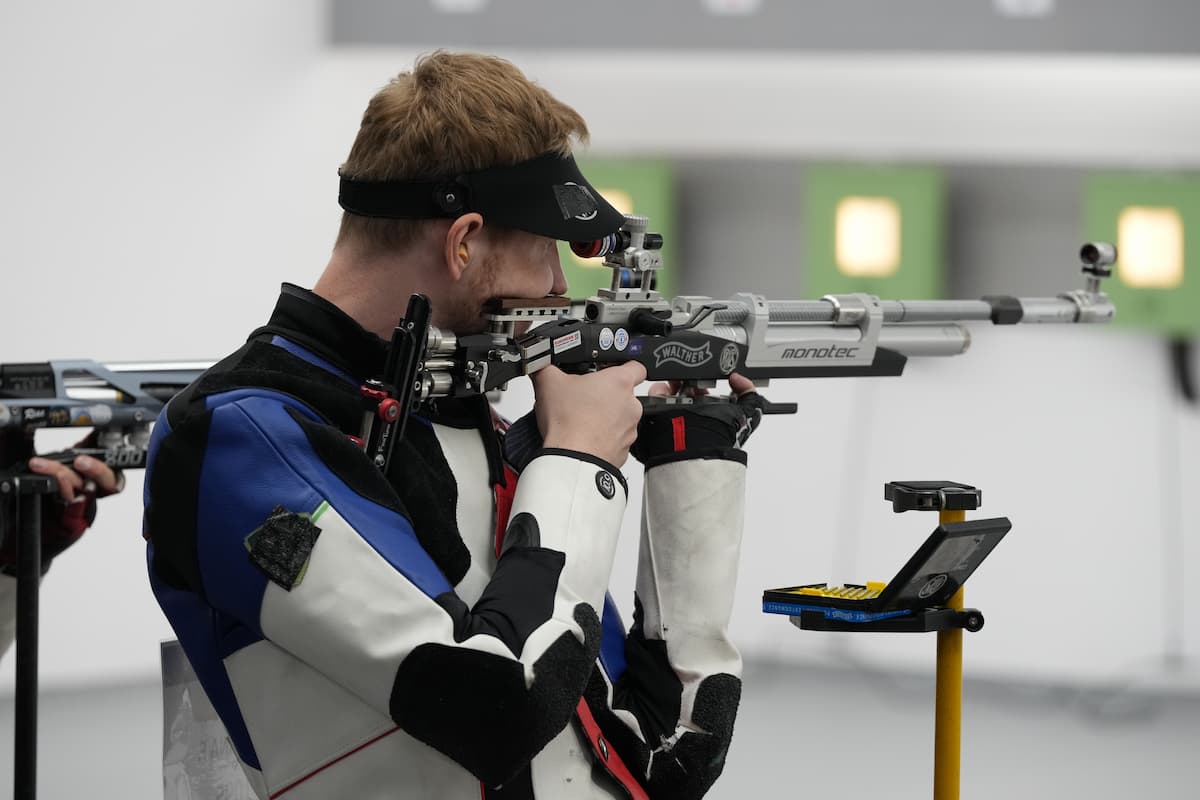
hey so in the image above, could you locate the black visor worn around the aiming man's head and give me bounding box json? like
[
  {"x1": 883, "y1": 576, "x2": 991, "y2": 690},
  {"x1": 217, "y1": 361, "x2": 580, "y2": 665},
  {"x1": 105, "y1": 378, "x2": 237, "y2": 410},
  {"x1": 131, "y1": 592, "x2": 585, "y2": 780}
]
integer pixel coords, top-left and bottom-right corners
[{"x1": 337, "y1": 154, "x2": 625, "y2": 241}]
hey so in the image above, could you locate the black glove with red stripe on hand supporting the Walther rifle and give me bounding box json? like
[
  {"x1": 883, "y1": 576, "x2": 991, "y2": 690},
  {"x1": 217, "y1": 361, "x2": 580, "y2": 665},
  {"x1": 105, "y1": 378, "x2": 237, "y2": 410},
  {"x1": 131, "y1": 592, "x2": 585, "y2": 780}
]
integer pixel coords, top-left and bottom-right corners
[{"x1": 629, "y1": 391, "x2": 767, "y2": 469}]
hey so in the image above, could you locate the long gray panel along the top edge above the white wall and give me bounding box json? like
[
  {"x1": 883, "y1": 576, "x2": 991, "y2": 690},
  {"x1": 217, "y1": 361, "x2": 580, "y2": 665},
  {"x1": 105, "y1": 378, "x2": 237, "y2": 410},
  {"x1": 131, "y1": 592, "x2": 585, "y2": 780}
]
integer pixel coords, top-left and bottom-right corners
[{"x1": 330, "y1": 0, "x2": 1200, "y2": 53}]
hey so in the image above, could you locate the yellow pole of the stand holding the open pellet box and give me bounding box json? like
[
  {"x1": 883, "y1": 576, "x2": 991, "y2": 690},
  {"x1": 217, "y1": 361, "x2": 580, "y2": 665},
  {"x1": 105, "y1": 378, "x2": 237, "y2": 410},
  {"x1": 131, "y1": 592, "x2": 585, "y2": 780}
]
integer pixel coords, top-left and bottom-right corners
[{"x1": 934, "y1": 510, "x2": 967, "y2": 800}]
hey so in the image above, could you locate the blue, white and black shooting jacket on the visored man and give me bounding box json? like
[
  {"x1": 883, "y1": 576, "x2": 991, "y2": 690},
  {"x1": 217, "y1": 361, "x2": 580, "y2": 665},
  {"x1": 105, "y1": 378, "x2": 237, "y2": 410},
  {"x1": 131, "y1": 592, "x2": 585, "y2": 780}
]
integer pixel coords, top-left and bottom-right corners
[{"x1": 144, "y1": 284, "x2": 745, "y2": 800}]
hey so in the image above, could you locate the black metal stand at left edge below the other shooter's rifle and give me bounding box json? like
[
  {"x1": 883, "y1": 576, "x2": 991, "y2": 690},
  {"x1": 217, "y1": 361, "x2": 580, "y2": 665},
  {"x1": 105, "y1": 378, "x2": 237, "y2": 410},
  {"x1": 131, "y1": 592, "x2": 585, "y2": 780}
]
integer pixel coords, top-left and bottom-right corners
[{"x1": 0, "y1": 475, "x2": 58, "y2": 800}]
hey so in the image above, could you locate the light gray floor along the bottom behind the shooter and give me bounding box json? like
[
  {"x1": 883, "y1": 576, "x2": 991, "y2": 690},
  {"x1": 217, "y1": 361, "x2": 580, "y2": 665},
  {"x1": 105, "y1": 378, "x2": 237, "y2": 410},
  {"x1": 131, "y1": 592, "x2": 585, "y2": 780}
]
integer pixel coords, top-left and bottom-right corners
[{"x1": 0, "y1": 663, "x2": 1200, "y2": 800}]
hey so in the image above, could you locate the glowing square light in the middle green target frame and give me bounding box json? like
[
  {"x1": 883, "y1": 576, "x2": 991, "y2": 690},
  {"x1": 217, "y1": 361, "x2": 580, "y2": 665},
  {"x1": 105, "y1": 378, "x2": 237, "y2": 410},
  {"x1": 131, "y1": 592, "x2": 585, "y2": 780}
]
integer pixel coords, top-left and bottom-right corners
[{"x1": 834, "y1": 197, "x2": 901, "y2": 278}]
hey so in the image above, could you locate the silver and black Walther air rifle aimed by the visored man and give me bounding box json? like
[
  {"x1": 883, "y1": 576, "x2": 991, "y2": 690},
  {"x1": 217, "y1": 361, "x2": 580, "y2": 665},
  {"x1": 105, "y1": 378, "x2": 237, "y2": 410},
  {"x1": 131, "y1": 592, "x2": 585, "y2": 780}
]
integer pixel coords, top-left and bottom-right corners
[{"x1": 362, "y1": 216, "x2": 1116, "y2": 465}]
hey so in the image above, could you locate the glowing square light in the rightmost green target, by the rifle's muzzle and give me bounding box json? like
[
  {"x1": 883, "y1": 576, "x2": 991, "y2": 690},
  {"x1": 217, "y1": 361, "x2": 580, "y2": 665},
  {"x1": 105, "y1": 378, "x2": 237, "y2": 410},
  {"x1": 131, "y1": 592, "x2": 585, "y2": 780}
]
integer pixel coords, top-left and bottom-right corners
[{"x1": 1117, "y1": 205, "x2": 1183, "y2": 289}]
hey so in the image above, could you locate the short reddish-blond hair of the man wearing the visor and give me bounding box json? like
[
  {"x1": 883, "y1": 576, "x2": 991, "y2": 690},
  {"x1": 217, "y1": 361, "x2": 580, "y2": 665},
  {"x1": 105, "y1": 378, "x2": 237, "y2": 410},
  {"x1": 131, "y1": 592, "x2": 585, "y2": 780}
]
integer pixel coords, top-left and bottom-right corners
[{"x1": 337, "y1": 50, "x2": 588, "y2": 252}]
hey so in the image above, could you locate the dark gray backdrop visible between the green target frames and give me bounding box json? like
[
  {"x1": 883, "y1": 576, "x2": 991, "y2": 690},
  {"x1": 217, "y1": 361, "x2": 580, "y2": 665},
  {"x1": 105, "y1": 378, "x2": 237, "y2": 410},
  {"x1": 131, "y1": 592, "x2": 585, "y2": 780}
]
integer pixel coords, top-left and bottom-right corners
[{"x1": 667, "y1": 160, "x2": 1086, "y2": 299}]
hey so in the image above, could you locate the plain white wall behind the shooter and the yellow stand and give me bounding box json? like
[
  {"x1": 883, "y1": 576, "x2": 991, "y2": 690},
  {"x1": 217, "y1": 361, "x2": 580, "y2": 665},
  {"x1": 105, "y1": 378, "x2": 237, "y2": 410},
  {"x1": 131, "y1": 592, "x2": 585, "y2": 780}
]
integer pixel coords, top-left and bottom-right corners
[{"x1": 0, "y1": 6, "x2": 1200, "y2": 685}]
